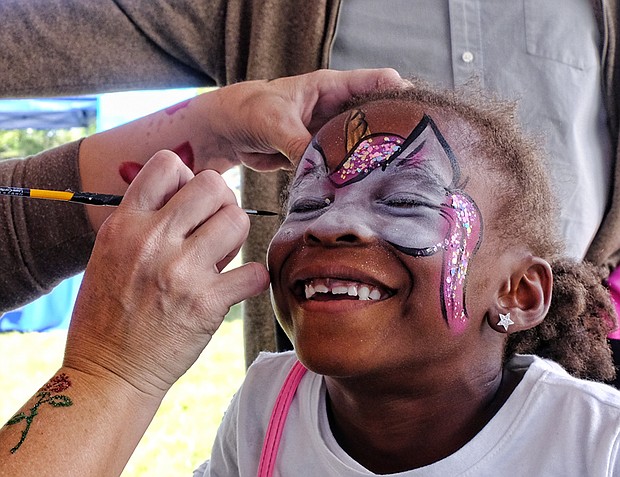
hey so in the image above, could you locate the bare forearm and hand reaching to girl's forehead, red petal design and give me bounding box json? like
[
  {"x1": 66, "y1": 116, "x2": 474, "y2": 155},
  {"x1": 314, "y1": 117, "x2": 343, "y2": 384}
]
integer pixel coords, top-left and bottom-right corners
[{"x1": 79, "y1": 69, "x2": 406, "y2": 230}]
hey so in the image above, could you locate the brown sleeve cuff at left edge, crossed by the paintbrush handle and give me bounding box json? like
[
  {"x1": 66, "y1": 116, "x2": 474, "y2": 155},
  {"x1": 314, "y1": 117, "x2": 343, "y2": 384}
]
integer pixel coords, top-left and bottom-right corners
[{"x1": 0, "y1": 141, "x2": 95, "y2": 312}]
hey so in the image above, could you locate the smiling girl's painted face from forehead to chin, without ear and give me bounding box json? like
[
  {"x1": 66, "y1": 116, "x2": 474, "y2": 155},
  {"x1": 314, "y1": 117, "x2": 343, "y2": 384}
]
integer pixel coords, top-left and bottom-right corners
[{"x1": 269, "y1": 101, "x2": 494, "y2": 375}]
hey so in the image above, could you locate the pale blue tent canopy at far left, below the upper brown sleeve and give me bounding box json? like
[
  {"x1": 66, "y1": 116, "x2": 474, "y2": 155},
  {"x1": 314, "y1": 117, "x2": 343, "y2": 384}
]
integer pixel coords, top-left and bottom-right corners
[{"x1": 0, "y1": 96, "x2": 97, "y2": 129}]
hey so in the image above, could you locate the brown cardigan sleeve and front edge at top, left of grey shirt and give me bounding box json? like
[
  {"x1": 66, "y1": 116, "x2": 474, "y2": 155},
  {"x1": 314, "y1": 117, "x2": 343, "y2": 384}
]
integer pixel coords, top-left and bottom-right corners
[{"x1": 0, "y1": 0, "x2": 340, "y2": 97}]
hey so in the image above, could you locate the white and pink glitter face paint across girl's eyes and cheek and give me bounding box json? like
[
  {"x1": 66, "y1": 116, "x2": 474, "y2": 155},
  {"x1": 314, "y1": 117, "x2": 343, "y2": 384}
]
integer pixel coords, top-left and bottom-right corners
[{"x1": 282, "y1": 115, "x2": 481, "y2": 331}]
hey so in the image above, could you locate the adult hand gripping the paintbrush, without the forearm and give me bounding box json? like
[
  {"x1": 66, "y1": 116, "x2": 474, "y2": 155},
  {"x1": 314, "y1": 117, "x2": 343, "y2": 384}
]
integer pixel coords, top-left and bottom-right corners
[{"x1": 64, "y1": 151, "x2": 269, "y2": 397}]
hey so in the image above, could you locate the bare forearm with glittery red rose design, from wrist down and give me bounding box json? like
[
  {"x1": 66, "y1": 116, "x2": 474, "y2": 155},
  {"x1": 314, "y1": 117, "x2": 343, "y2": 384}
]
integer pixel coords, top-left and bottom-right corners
[{"x1": 0, "y1": 367, "x2": 161, "y2": 477}]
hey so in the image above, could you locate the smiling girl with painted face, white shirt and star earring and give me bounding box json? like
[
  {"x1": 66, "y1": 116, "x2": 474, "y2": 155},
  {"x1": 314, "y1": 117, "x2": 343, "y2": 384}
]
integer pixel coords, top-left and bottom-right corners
[{"x1": 203, "y1": 85, "x2": 620, "y2": 476}]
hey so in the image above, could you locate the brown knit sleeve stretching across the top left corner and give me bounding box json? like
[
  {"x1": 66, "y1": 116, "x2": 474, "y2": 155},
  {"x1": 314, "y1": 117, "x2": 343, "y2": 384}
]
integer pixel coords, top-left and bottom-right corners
[{"x1": 0, "y1": 0, "x2": 226, "y2": 97}]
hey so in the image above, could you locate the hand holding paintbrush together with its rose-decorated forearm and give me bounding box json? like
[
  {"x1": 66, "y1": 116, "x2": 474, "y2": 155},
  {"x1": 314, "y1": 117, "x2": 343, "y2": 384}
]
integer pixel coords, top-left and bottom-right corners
[{"x1": 0, "y1": 152, "x2": 269, "y2": 477}]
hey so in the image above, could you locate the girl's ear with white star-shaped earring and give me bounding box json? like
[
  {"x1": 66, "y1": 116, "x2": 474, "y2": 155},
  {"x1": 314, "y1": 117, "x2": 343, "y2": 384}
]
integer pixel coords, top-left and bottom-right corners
[{"x1": 488, "y1": 256, "x2": 553, "y2": 333}]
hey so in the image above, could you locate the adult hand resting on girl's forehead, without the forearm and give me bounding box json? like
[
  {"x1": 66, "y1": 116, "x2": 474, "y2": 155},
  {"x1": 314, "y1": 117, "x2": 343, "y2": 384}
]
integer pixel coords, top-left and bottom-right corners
[{"x1": 195, "y1": 68, "x2": 406, "y2": 171}]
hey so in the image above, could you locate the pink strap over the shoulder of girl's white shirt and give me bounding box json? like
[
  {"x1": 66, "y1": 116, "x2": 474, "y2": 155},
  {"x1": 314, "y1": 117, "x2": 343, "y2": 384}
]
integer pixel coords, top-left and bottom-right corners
[{"x1": 258, "y1": 361, "x2": 307, "y2": 477}]
